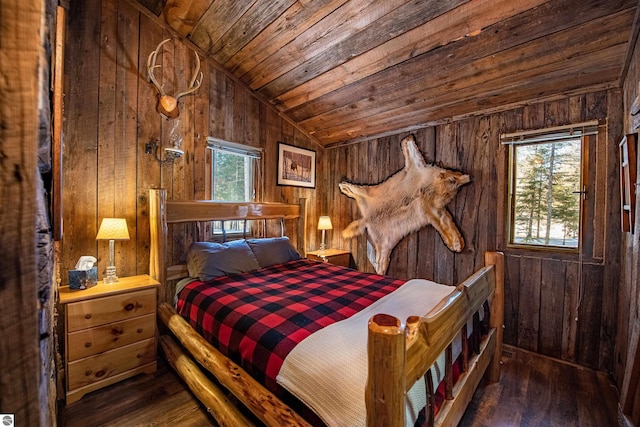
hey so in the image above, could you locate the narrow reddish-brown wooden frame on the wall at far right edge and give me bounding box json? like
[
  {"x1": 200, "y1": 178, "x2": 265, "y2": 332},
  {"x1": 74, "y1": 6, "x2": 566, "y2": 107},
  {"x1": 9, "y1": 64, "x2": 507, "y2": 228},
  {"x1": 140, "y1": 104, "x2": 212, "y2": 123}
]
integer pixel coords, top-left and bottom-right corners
[{"x1": 618, "y1": 133, "x2": 638, "y2": 234}]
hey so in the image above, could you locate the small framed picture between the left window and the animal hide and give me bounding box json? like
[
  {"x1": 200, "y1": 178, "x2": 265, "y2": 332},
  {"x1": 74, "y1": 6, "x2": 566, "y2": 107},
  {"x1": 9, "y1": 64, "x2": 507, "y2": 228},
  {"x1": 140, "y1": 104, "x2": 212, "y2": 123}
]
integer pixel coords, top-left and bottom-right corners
[{"x1": 276, "y1": 142, "x2": 316, "y2": 188}]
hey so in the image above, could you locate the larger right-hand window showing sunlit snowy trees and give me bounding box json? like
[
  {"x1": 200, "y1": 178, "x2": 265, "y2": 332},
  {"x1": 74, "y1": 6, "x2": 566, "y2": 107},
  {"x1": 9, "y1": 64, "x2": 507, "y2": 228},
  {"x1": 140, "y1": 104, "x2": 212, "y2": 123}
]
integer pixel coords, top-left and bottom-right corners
[{"x1": 501, "y1": 122, "x2": 597, "y2": 251}]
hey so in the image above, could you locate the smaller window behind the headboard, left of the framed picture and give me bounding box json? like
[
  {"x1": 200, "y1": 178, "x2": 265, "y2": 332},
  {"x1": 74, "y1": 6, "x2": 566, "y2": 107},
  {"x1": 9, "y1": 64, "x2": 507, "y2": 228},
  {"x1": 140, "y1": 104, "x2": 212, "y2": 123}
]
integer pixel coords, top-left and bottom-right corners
[{"x1": 207, "y1": 137, "x2": 262, "y2": 234}]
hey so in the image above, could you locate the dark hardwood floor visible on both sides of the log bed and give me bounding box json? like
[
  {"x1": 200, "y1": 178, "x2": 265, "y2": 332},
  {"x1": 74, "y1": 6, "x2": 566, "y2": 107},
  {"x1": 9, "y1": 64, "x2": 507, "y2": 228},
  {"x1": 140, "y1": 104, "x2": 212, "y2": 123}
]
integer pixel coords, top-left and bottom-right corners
[{"x1": 59, "y1": 347, "x2": 617, "y2": 427}]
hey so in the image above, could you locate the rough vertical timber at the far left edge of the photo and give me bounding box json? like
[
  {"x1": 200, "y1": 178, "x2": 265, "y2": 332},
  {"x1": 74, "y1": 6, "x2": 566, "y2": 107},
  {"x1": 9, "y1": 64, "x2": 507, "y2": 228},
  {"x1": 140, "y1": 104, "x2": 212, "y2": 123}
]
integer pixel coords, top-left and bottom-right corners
[{"x1": 0, "y1": 1, "x2": 45, "y2": 426}]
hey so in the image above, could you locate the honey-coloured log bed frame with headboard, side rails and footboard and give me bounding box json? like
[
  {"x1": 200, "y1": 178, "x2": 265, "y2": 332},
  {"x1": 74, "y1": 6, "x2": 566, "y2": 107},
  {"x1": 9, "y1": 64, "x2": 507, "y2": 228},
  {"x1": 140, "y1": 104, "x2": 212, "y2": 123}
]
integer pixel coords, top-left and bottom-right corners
[{"x1": 149, "y1": 189, "x2": 504, "y2": 426}]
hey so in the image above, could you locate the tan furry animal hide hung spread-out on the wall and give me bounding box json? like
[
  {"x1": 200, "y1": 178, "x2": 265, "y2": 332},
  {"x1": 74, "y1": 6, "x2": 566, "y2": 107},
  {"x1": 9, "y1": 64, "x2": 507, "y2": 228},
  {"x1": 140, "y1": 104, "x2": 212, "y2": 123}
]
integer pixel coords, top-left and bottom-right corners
[{"x1": 338, "y1": 135, "x2": 471, "y2": 274}]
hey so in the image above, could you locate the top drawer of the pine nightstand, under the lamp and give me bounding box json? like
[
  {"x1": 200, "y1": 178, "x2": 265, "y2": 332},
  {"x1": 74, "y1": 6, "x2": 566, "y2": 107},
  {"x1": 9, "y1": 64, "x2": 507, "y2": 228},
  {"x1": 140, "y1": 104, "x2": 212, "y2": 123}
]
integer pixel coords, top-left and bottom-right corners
[{"x1": 67, "y1": 289, "x2": 156, "y2": 332}]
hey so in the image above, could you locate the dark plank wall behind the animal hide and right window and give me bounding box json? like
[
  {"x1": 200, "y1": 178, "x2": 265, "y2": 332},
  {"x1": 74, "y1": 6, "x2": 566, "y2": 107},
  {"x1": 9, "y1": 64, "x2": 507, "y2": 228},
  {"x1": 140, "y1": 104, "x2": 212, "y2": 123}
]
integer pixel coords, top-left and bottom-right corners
[{"x1": 322, "y1": 90, "x2": 622, "y2": 372}]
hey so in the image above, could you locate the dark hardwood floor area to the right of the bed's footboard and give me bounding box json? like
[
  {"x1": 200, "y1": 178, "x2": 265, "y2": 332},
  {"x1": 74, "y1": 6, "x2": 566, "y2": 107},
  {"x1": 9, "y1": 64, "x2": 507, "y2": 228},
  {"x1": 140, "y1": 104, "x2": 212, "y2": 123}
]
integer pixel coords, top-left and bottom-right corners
[{"x1": 460, "y1": 346, "x2": 618, "y2": 427}]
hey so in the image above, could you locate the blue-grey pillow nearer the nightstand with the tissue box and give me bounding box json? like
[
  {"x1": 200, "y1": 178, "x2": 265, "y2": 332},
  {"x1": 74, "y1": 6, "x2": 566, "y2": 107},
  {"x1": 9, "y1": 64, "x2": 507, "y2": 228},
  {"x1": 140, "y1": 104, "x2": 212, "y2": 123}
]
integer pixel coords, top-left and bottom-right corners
[{"x1": 187, "y1": 240, "x2": 260, "y2": 282}]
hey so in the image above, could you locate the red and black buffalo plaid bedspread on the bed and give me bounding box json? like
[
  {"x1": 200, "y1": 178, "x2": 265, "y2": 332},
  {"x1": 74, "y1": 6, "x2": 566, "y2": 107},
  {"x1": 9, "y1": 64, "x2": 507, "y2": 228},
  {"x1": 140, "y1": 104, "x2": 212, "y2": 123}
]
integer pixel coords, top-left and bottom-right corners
[{"x1": 177, "y1": 259, "x2": 404, "y2": 391}]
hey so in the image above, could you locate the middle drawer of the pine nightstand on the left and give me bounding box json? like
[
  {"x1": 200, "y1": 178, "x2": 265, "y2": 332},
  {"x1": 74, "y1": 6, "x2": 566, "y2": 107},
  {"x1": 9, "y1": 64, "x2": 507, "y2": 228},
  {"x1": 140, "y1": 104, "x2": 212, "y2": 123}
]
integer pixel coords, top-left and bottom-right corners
[{"x1": 67, "y1": 313, "x2": 156, "y2": 362}]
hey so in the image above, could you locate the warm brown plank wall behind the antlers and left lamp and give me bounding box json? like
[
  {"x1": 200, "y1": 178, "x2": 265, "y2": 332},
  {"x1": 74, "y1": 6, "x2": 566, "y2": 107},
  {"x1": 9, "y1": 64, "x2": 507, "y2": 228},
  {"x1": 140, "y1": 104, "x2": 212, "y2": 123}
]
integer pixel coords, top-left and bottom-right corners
[{"x1": 61, "y1": 0, "x2": 322, "y2": 284}]
